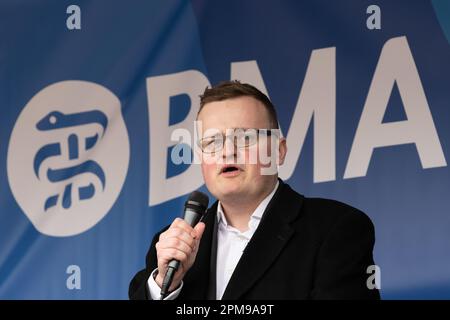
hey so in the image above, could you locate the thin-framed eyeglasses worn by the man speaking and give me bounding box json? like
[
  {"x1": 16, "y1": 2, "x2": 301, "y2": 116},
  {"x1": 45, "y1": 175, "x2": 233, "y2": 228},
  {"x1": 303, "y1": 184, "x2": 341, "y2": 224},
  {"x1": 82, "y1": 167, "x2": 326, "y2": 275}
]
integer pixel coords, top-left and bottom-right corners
[{"x1": 198, "y1": 128, "x2": 279, "y2": 153}]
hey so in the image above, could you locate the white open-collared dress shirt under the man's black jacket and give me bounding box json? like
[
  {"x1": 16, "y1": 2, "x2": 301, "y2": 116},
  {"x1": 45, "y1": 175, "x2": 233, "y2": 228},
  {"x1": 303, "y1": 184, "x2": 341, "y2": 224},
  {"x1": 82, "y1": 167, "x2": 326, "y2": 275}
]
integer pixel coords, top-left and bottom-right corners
[{"x1": 147, "y1": 181, "x2": 279, "y2": 300}]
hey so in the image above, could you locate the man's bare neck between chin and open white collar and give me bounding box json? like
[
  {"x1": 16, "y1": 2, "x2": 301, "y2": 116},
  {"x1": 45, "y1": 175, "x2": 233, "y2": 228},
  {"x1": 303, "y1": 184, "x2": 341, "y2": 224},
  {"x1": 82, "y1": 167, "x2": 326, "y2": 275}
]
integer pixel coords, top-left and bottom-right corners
[{"x1": 220, "y1": 181, "x2": 276, "y2": 232}]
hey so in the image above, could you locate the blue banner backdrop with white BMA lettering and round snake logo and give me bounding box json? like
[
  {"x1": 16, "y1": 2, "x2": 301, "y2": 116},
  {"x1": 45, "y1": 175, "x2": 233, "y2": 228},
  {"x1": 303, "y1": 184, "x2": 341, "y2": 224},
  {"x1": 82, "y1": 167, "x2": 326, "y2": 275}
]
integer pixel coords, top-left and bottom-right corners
[{"x1": 0, "y1": 0, "x2": 450, "y2": 299}]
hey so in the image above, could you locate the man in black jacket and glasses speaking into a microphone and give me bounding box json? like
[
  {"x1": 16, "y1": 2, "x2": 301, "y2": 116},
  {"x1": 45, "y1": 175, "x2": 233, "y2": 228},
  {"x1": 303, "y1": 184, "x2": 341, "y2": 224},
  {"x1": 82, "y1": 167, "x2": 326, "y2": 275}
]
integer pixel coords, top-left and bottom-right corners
[{"x1": 129, "y1": 81, "x2": 379, "y2": 299}]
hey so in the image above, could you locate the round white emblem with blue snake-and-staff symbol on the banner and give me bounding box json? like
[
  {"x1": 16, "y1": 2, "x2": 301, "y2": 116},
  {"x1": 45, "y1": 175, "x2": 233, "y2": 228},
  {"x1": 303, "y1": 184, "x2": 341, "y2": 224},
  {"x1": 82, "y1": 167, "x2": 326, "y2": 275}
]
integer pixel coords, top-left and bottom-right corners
[{"x1": 7, "y1": 81, "x2": 130, "y2": 236}]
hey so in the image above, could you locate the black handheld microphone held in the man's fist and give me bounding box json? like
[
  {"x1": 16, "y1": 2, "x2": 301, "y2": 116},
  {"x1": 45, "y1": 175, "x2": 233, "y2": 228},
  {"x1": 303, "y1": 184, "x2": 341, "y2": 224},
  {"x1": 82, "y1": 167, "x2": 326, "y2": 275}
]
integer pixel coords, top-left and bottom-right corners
[{"x1": 160, "y1": 191, "x2": 209, "y2": 300}]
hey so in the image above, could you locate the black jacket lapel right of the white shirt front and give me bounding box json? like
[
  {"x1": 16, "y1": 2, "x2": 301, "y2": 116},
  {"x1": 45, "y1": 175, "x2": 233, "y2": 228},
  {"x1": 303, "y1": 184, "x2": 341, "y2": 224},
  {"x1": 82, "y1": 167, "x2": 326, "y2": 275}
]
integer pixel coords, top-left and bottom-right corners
[{"x1": 222, "y1": 180, "x2": 303, "y2": 300}]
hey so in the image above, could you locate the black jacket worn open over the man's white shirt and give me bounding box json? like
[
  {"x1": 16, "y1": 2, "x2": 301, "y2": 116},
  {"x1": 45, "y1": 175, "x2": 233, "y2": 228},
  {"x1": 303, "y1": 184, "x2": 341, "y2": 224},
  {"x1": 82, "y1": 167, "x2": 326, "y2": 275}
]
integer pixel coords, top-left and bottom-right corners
[{"x1": 129, "y1": 180, "x2": 380, "y2": 300}]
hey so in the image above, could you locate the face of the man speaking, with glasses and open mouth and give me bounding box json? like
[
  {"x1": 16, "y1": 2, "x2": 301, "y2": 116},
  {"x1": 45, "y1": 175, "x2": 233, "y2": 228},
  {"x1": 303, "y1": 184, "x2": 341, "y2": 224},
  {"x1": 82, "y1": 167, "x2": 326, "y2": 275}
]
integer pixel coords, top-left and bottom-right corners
[{"x1": 198, "y1": 97, "x2": 286, "y2": 201}]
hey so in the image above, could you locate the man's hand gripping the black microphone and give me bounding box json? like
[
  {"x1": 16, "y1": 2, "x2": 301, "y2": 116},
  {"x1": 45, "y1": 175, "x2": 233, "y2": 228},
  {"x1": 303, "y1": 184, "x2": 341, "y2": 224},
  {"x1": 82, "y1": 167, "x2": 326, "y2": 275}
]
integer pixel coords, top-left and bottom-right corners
[{"x1": 155, "y1": 218, "x2": 205, "y2": 292}]
